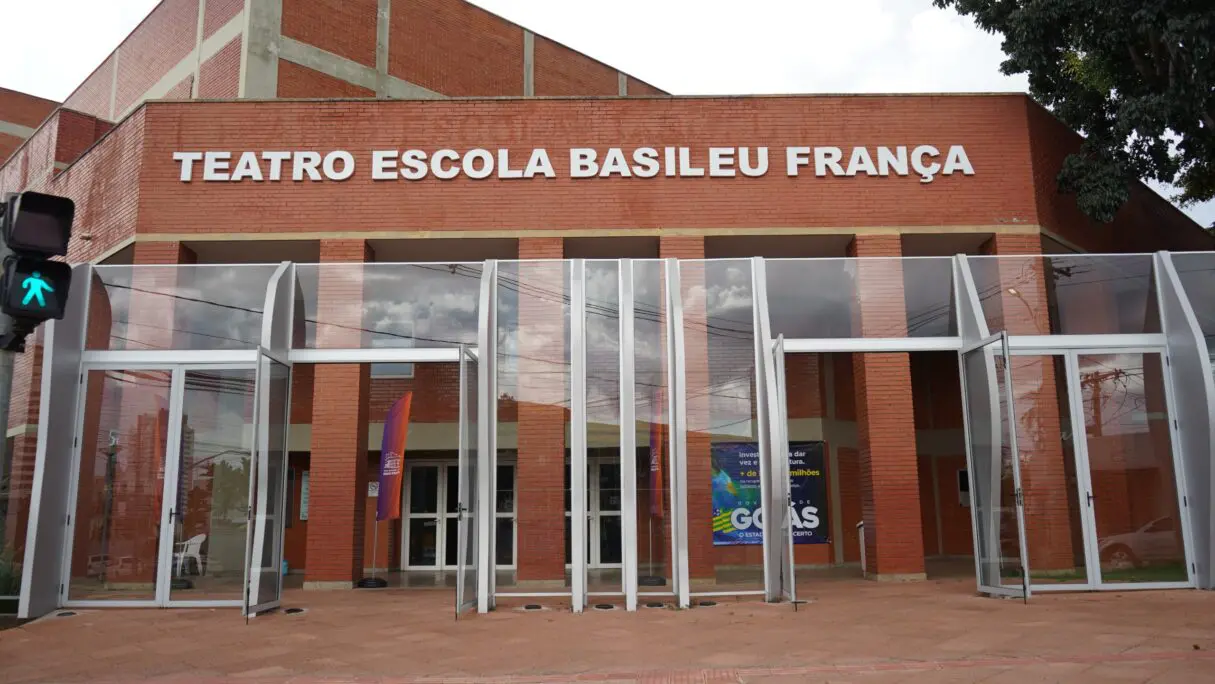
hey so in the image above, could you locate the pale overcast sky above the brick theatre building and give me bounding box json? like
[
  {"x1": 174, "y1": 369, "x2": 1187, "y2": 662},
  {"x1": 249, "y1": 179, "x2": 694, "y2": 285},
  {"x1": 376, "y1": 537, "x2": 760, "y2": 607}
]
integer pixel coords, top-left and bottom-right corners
[{"x1": 0, "y1": 0, "x2": 1215, "y2": 226}]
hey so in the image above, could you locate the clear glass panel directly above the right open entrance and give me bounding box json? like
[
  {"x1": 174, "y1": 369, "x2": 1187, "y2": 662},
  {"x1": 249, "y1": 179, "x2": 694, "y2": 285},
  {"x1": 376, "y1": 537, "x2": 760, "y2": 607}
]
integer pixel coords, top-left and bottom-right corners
[{"x1": 765, "y1": 256, "x2": 957, "y2": 338}]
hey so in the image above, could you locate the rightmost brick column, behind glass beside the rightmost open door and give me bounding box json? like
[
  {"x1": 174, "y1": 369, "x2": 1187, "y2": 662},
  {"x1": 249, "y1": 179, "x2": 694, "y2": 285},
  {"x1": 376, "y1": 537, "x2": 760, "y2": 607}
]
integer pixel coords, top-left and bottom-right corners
[{"x1": 983, "y1": 234, "x2": 1084, "y2": 572}]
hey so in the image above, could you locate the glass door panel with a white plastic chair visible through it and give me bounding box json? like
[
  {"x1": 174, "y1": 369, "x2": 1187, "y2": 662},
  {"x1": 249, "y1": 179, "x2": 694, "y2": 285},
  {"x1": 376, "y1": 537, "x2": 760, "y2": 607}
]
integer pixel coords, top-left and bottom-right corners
[{"x1": 169, "y1": 368, "x2": 256, "y2": 600}]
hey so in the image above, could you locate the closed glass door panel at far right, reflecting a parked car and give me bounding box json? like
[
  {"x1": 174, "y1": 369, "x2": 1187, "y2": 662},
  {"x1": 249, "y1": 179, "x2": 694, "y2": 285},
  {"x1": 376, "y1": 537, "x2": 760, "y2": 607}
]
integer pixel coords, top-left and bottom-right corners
[{"x1": 1079, "y1": 354, "x2": 1189, "y2": 582}]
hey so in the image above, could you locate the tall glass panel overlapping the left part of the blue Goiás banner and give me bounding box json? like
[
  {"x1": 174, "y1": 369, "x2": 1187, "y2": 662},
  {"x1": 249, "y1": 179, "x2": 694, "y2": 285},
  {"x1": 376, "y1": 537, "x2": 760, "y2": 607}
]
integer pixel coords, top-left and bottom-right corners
[{"x1": 679, "y1": 260, "x2": 764, "y2": 593}]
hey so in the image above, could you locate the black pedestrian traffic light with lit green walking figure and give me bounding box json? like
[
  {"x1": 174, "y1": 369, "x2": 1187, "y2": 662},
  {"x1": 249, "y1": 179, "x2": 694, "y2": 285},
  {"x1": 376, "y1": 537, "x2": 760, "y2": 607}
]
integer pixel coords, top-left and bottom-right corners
[{"x1": 0, "y1": 192, "x2": 75, "y2": 351}]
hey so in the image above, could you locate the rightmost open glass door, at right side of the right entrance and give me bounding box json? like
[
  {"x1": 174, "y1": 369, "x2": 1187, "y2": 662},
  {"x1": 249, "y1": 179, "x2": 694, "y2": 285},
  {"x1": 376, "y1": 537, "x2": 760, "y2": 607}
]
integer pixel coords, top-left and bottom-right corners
[{"x1": 961, "y1": 333, "x2": 1029, "y2": 598}]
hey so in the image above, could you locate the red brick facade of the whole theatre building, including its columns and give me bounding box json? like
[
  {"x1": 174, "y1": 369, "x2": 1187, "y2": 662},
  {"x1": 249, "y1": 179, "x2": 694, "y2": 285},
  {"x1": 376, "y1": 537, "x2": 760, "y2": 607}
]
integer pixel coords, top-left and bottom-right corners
[{"x1": 0, "y1": 0, "x2": 1215, "y2": 600}]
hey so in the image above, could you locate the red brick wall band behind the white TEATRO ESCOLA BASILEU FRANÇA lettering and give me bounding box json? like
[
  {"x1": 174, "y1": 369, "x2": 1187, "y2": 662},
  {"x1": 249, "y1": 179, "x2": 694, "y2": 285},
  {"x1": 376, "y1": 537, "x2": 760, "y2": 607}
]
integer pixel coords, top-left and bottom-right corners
[{"x1": 135, "y1": 96, "x2": 1035, "y2": 239}]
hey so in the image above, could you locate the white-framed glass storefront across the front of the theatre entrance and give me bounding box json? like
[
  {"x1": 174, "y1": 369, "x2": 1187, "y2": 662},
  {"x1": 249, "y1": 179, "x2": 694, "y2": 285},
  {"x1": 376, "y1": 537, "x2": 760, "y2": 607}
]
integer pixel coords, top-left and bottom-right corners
[{"x1": 7, "y1": 253, "x2": 1215, "y2": 622}]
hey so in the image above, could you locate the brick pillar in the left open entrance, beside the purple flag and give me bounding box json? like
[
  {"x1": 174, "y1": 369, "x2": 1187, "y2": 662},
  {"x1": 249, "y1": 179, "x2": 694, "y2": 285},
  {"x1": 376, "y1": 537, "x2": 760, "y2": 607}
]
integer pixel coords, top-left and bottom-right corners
[{"x1": 304, "y1": 239, "x2": 373, "y2": 589}]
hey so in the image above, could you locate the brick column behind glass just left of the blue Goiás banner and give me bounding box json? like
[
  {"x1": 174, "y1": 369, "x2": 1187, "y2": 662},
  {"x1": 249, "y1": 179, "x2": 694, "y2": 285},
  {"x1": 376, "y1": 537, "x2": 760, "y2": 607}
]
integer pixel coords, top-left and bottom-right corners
[{"x1": 659, "y1": 236, "x2": 717, "y2": 580}]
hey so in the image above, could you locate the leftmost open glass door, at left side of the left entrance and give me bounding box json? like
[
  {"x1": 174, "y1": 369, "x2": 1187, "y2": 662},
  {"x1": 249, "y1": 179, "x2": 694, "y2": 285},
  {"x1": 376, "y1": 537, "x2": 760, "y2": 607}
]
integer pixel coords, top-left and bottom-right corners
[{"x1": 244, "y1": 349, "x2": 292, "y2": 616}]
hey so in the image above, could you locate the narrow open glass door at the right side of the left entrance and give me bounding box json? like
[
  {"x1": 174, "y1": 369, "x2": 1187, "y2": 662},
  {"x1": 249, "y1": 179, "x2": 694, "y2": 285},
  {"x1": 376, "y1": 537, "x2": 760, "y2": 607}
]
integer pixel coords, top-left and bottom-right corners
[{"x1": 456, "y1": 346, "x2": 479, "y2": 616}]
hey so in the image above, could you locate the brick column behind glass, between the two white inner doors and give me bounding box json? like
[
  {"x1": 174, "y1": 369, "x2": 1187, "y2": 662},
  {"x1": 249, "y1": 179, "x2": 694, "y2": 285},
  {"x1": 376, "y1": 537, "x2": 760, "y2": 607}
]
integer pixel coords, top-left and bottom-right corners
[{"x1": 515, "y1": 238, "x2": 570, "y2": 586}]
